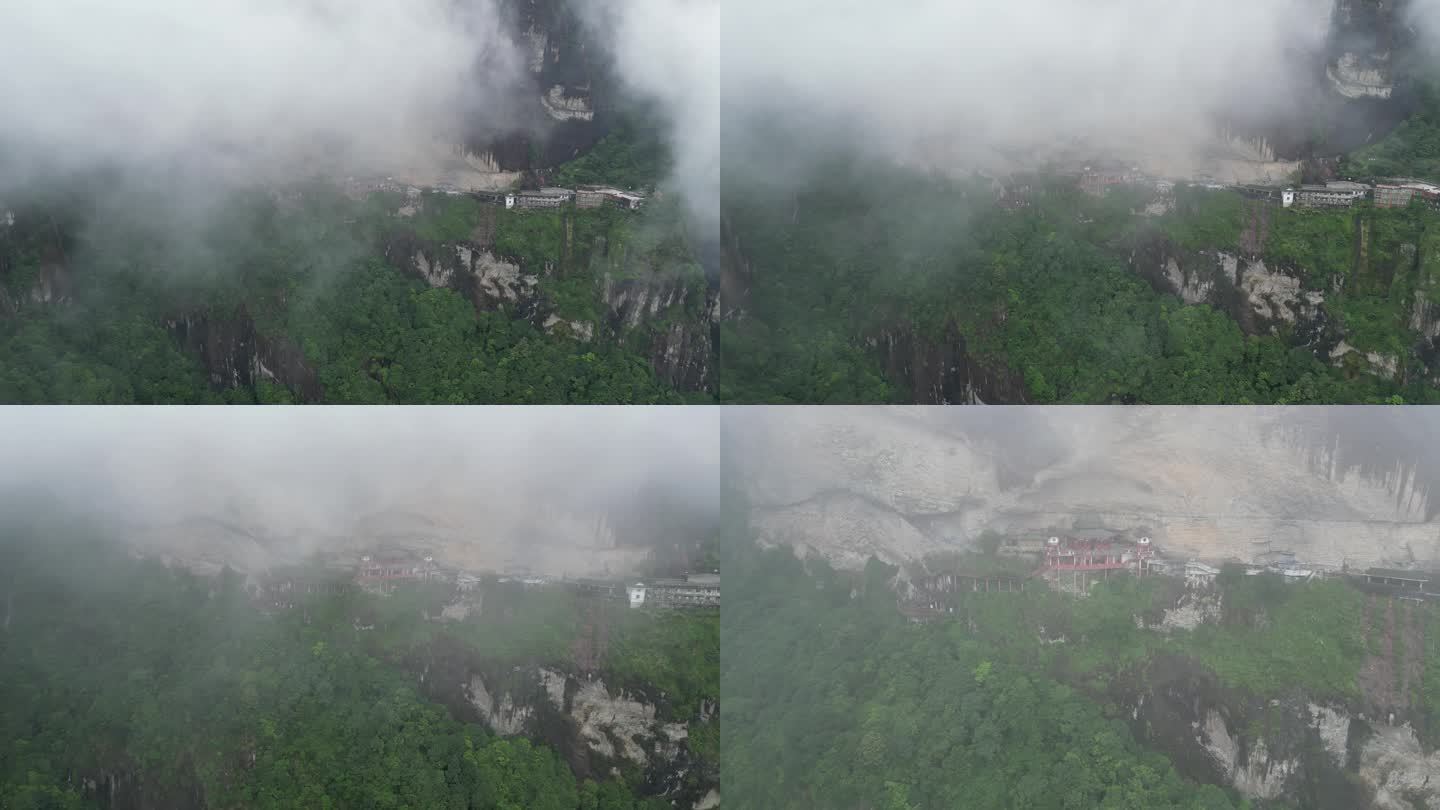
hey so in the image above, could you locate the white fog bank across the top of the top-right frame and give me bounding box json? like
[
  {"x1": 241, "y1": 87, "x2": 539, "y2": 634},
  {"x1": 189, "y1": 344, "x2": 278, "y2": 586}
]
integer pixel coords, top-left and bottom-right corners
[{"x1": 723, "y1": 0, "x2": 1353, "y2": 188}]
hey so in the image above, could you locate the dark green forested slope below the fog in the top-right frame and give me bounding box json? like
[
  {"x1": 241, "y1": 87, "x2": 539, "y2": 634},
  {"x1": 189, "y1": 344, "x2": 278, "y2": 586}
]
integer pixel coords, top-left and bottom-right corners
[{"x1": 720, "y1": 163, "x2": 1440, "y2": 404}]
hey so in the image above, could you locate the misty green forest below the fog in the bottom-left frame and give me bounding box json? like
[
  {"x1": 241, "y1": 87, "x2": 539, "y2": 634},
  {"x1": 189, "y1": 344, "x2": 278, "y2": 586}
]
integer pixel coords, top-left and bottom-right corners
[{"x1": 0, "y1": 515, "x2": 719, "y2": 810}]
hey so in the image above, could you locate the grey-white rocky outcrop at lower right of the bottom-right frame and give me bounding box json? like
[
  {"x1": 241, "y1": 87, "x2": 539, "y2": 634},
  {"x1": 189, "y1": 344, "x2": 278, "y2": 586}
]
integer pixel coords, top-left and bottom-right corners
[{"x1": 1104, "y1": 573, "x2": 1440, "y2": 810}]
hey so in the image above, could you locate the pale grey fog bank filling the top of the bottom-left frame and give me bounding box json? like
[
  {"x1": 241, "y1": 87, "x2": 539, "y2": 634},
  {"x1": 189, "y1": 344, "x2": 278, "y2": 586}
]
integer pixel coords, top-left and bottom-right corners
[{"x1": 0, "y1": 406, "x2": 719, "y2": 575}]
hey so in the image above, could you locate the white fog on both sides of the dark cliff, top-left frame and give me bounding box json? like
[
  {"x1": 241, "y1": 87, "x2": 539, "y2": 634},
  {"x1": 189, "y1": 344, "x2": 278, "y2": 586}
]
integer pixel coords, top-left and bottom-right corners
[{"x1": 0, "y1": 0, "x2": 720, "y2": 222}]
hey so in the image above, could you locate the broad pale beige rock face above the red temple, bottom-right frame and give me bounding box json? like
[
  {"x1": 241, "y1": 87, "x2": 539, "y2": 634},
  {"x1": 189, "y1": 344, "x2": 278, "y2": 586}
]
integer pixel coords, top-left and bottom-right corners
[{"x1": 724, "y1": 408, "x2": 1440, "y2": 568}]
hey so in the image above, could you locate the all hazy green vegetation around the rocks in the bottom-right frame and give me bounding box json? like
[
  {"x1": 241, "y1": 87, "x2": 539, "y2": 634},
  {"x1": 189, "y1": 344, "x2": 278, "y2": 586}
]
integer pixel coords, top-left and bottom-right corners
[{"x1": 721, "y1": 498, "x2": 1440, "y2": 810}]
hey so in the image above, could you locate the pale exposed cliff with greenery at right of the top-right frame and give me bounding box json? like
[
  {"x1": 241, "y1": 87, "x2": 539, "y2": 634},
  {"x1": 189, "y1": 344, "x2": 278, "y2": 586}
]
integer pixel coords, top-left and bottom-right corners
[{"x1": 1128, "y1": 202, "x2": 1440, "y2": 383}]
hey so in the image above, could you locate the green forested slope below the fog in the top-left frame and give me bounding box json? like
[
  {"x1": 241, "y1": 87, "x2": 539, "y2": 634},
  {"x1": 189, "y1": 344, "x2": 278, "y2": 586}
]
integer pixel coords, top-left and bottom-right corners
[{"x1": 0, "y1": 146, "x2": 713, "y2": 404}]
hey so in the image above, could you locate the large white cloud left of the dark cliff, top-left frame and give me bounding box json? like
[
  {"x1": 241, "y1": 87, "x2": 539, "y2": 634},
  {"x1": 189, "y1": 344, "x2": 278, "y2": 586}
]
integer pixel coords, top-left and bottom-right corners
[{"x1": 0, "y1": 0, "x2": 523, "y2": 190}]
